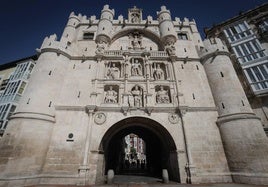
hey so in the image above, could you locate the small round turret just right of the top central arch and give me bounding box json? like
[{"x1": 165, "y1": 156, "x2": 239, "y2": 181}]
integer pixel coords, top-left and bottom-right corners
[{"x1": 157, "y1": 6, "x2": 177, "y2": 45}]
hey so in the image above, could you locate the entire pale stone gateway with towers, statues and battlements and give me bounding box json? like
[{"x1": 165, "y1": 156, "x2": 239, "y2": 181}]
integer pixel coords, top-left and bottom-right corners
[{"x1": 0, "y1": 5, "x2": 268, "y2": 186}]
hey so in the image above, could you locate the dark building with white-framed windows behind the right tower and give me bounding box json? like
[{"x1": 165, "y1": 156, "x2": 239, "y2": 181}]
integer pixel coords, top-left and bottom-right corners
[{"x1": 205, "y1": 3, "x2": 268, "y2": 135}]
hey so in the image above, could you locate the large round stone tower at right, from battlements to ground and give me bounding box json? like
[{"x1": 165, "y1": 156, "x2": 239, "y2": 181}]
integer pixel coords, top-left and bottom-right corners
[{"x1": 201, "y1": 38, "x2": 268, "y2": 184}]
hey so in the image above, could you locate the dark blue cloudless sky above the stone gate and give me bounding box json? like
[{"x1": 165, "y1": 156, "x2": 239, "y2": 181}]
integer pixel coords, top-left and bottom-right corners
[{"x1": 0, "y1": 0, "x2": 267, "y2": 64}]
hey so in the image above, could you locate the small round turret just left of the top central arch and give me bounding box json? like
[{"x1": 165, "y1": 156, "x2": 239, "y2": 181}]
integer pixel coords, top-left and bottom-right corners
[{"x1": 96, "y1": 5, "x2": 114, "y2": 43}]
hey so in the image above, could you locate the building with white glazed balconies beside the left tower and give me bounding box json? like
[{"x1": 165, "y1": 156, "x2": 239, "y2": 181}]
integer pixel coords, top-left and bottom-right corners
[{"x1": 0, "y1": 56, "x2": 37, "y2": 136}]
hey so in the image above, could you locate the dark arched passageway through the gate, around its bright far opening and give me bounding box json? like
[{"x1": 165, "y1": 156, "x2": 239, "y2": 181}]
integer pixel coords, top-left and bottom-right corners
[{"x1": 100, "y1": 117, "x2": 180, "y2": 182}]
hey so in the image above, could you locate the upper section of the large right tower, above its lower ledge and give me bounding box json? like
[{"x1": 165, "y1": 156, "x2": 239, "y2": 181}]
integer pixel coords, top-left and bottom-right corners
[{"x1": 201, "y1": 38, "x2": 253, "y2": 116}]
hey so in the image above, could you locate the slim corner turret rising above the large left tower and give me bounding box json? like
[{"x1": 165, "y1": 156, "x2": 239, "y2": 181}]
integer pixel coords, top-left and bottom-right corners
[{"x1": 61, "y1": 12, "x2": 80, "y2": 42}]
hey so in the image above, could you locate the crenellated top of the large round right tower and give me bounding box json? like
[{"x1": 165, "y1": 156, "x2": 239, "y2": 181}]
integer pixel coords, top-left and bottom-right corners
[{"x1": 198, "y1": 38, "x2": 230, "y2": 60}]
